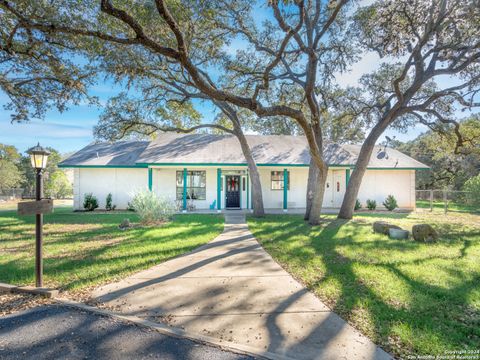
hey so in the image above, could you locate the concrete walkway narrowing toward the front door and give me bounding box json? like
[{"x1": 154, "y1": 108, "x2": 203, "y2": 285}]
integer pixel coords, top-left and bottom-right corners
[{"x1": 93, "y1": 214, "x2": 390, "y2": 359}]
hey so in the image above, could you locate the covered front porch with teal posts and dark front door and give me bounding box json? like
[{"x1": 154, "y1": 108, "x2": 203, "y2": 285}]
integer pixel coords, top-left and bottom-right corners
[{"x1": 148, "y1": 164, "x2": 308, "y2": 213}]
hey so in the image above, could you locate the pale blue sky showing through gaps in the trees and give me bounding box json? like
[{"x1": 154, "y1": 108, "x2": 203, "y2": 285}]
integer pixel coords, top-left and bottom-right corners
[{"x1": 0, "y1": 0, "x2": 472, "y2": 153}]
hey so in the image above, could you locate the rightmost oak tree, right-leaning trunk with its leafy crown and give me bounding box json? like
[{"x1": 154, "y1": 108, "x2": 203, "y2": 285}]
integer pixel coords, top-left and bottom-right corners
[{"x1": 339, "y1": 0, "x2": 480, "y2": 218}]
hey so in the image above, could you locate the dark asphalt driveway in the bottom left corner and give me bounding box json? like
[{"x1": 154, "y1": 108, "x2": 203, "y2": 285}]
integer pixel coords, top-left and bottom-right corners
[{"x1": 0, "y1": 306, "x2": 253, "y2": 360}]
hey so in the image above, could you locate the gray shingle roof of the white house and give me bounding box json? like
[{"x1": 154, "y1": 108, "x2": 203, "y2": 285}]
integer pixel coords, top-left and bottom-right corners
[{"x1": 61, "y1": 133, "x2": 428, "y2": 169}]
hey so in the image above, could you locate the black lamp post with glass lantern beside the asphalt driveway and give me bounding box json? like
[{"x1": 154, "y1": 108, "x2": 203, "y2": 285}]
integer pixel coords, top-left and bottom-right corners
[{"x1": 28, "y1": 143, "x2": 50, "y2": 287}]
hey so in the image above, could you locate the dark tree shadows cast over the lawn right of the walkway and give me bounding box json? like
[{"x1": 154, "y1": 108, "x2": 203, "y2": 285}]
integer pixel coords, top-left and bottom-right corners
[{"x1": 249, "y1": 215, "x2": 480, "y2": 355}]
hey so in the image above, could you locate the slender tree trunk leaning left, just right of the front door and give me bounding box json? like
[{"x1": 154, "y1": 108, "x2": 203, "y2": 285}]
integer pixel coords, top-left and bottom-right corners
[{"x1": 234, "y1": 125, "x2": 265, "y2": 217}]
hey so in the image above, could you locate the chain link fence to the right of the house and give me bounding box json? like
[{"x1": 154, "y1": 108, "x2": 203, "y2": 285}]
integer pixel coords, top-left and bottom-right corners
[{"x1": 415, "y1": 190, "x2": 480, "y2": 214}]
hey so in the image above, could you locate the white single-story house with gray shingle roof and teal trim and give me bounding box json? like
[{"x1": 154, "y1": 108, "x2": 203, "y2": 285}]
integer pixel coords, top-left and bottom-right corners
[{"x1": 59, "y1": 133, "x2": 428, "y2": 211}]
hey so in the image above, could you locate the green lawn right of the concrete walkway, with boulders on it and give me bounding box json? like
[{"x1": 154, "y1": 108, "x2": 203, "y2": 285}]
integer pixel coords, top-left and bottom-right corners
[{"x1": 248, "y1": 213, "x2": 480, "y2": 357}]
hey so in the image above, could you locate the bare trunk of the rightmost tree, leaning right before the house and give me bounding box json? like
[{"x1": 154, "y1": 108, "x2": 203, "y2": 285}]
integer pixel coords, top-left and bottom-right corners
[{"x1": 338, "y1": 124, "x2": 386, "y2": 219}]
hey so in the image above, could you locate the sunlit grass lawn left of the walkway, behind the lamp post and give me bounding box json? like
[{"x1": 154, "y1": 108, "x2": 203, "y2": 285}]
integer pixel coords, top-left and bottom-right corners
[{"x1": 0, "y1": 208, "x2": 223, "y2": 291}]
